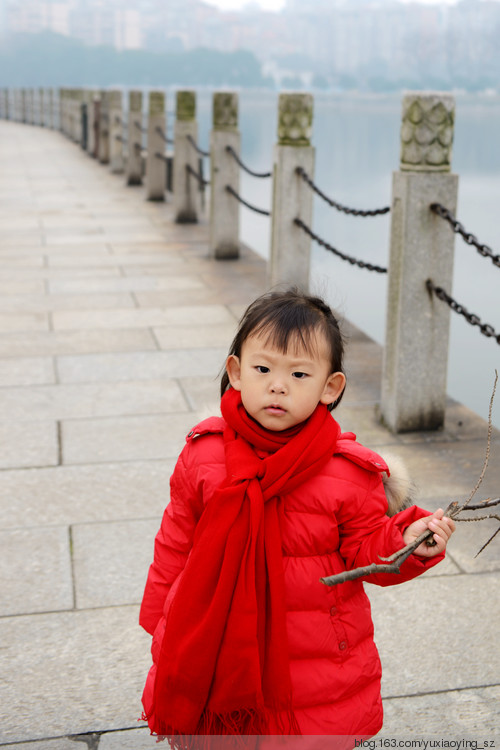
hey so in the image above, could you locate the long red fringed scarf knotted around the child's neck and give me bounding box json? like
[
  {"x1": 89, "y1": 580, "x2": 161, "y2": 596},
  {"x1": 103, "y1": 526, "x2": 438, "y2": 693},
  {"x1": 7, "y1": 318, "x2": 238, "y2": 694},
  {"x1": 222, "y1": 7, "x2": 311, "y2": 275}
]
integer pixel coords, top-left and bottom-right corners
[{"x1": 148, "y1": 388, "x2": 340, "y2": 746}]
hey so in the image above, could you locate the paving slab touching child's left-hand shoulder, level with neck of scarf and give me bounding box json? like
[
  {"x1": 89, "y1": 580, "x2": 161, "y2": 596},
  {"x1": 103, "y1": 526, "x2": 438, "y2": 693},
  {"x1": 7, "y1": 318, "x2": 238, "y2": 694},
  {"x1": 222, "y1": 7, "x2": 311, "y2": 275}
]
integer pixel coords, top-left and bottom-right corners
[{"x1": 62, "y1": 412, "x2": 199, "y2": 464}]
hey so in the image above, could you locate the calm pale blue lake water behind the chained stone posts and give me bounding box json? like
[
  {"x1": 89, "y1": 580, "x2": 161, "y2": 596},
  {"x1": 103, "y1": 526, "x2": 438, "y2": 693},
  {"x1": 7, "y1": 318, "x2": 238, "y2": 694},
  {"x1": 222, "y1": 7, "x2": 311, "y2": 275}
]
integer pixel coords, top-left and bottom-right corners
[{"x1": 193, "y1": 91, "x2": 500, "y2": 427}]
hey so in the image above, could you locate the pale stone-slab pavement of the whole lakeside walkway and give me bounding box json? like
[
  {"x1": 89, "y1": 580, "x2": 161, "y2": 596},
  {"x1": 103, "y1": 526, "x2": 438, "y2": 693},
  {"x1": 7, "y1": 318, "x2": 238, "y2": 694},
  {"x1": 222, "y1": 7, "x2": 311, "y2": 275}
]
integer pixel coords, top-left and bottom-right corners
[{"x1": 0, "y1": 121, "x2": 500, "y2": 750}]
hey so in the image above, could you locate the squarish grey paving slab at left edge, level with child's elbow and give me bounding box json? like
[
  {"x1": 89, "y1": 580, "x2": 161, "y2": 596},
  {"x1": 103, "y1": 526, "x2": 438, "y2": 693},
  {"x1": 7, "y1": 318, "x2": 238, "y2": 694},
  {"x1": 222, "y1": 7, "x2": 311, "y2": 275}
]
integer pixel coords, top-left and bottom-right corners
[{"x1": 0, "y1": 519, "x2": 73, "y2": 617}]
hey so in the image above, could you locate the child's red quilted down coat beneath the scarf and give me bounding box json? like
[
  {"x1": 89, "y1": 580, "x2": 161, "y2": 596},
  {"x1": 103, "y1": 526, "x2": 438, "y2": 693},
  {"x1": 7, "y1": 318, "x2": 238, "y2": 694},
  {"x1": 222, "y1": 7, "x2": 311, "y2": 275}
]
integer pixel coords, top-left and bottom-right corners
[{"x1": 140, "y1": 417, "x2": 442, "y2": 737}]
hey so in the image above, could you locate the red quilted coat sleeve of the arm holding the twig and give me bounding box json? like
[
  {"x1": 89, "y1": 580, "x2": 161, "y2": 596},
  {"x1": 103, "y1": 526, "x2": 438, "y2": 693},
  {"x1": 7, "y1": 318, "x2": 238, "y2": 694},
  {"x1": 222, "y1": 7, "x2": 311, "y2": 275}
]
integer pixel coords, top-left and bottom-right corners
[{"x1": 339, "y1": 473, "x2": 444, "y2": 586}]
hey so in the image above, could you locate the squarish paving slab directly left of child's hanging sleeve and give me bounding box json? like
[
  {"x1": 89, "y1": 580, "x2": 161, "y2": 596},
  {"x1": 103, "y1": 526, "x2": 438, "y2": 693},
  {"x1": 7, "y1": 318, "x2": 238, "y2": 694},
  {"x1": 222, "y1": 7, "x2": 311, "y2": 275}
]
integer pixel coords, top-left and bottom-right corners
[{"x1": 72, "y1": 517, "x2": 161, "y2": 609}]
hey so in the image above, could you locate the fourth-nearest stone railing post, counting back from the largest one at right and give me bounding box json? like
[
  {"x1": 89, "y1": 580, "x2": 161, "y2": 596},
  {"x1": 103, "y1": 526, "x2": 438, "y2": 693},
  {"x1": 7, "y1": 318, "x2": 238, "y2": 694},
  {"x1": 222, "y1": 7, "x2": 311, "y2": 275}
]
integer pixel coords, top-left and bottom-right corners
[{"x1": 173, "y1": 91, "x2": 201, "y2": 224}]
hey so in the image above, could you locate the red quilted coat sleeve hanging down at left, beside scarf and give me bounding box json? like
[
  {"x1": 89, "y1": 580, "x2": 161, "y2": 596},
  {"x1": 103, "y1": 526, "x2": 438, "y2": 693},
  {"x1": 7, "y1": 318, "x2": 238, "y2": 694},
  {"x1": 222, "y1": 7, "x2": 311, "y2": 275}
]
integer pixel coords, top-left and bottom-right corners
[{"x1": 139, "y1": 445, "x2": 202, "y2": 634}]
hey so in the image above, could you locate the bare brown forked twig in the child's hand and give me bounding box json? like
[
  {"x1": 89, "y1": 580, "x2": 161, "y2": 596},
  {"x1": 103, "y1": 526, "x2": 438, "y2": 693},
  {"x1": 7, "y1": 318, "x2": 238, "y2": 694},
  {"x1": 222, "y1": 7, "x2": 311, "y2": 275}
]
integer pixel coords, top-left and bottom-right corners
[{"x1": 320, "y1": 370, "x2": 500, "y2": 586}]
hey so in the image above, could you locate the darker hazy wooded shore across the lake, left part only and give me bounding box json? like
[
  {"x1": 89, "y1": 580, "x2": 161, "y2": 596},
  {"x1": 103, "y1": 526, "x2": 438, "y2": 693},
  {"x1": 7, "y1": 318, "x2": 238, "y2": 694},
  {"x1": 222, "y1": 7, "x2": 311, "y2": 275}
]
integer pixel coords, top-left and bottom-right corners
[{"x1": 0, "y1": 32, "x2": 273, "y2": 88}]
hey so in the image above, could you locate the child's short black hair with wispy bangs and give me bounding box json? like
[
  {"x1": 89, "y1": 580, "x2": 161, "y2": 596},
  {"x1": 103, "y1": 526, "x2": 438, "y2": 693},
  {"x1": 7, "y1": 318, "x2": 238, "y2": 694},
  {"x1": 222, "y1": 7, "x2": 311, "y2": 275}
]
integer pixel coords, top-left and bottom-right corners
[{"x1": 221, "y1": 288, "x2": 344, "y2": 411}]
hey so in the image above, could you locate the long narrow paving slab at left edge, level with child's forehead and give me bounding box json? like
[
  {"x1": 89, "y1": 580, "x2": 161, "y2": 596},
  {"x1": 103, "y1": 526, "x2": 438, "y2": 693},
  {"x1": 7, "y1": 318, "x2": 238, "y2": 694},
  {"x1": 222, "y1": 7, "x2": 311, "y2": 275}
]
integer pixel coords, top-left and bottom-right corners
[{"x1": 0, "y1": 328, "x2": 156, "y2": 357}]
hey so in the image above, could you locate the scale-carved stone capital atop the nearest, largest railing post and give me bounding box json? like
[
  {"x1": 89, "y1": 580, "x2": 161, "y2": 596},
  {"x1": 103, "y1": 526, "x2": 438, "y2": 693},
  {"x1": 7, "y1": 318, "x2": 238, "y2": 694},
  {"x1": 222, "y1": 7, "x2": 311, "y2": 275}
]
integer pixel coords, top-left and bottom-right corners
[{"x1": 400, "y1": 92, "x2": 455, "y2": 172}]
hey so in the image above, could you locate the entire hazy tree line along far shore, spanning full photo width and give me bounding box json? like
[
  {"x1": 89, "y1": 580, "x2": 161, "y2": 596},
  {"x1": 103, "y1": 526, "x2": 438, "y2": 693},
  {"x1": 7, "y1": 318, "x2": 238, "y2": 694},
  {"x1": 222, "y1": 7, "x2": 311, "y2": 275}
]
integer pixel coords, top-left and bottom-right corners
[{"x1": 0, "y1": 31, "x2": 500, "y2": 93}]
